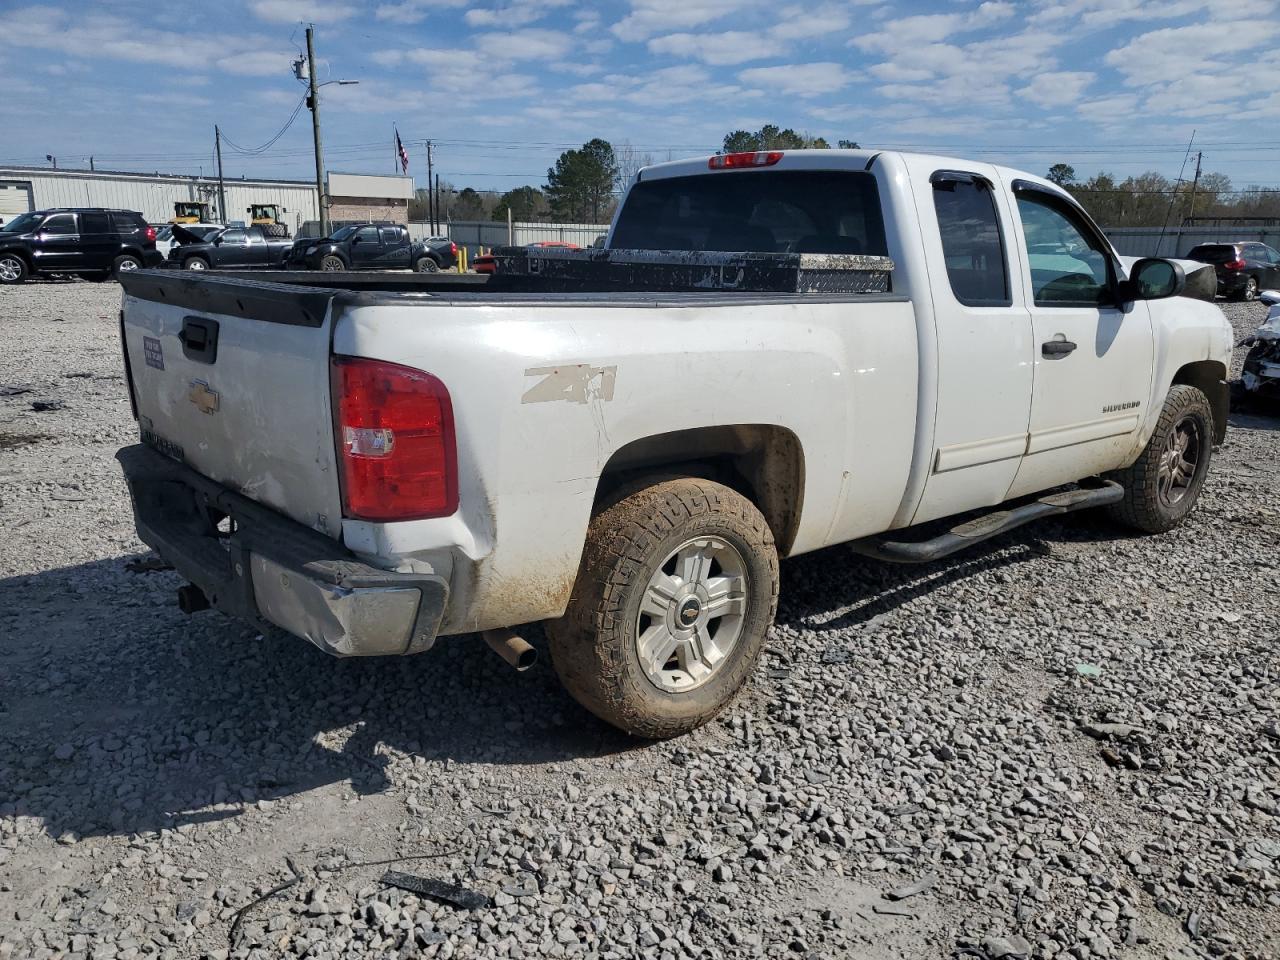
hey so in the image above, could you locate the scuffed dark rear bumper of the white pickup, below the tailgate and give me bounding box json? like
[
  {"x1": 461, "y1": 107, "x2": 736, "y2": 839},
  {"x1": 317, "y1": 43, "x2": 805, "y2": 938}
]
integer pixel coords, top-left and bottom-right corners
[{"x1": 115, "y1": 444, "x2": 449, "y2": 657}]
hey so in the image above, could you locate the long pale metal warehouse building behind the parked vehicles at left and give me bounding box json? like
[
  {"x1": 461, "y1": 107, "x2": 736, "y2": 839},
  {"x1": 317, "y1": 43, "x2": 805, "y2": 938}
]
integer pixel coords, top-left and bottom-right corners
[{"x1": 0, "y1": 166, "x2": 413, "y2": 233}]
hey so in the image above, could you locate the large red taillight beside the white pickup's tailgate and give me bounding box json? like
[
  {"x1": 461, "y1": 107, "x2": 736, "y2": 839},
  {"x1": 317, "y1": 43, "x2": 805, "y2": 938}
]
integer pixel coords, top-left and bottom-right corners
[{"x1": 333, "y1": 357, "x2": 458, "y2": 521}]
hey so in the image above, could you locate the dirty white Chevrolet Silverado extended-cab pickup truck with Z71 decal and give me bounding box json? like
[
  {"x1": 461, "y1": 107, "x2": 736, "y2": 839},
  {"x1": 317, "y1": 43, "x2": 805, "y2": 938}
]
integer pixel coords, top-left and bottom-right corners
[{"x1": 119, "y1": 150, "x2": 1233, "y2": 737}]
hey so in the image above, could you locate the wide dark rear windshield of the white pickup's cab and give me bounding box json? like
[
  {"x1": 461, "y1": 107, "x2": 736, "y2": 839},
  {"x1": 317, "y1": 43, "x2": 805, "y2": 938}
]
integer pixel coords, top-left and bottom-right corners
[{"x1": 611, "y1": 170, "x2": 887, "y2": 256}]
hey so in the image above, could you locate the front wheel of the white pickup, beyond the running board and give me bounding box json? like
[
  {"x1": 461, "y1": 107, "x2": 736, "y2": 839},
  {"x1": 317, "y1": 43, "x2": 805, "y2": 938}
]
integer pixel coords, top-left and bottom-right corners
[{"x1": 1108, "y1": 384, "x2": 1213, "y2": 534}]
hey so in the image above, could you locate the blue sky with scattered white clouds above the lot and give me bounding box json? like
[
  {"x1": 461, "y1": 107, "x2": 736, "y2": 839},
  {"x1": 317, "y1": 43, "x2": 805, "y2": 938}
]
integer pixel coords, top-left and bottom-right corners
[{"x1": 0, "y1": 0, "x2": 1280, "y2": 189}]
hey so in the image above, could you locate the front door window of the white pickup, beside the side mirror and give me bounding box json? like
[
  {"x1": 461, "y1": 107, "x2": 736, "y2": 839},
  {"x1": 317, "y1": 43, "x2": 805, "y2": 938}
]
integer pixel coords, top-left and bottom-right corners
[{"x1": 1018, "y1": 191, "x2": 1112, "y2": 307}]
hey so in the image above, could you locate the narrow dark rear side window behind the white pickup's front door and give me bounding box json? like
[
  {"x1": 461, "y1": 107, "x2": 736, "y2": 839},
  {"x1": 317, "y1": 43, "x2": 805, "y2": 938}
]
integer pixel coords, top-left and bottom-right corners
[{"x1": 933, "y1": 177, "x2": 1014, "y2": 307}]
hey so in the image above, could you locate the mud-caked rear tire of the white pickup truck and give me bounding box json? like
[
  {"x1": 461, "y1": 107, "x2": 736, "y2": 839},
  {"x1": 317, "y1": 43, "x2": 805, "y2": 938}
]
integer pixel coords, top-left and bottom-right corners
[{"x1": 547, "y1": 477, "x2": 778, "y2": 739}]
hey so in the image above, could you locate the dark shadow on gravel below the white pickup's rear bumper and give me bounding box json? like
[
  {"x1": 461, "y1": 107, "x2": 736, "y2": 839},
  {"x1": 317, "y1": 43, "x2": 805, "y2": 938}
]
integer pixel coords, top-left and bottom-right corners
[{"x1": 0, "y1": 554, "x2": 637, "y2": 837}]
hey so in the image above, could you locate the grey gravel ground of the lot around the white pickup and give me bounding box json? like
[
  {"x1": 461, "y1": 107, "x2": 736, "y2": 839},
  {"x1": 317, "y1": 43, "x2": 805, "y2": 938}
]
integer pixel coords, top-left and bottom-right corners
[{"x1": 0, "y1": 283, "x2": 1280, "y2": 960}]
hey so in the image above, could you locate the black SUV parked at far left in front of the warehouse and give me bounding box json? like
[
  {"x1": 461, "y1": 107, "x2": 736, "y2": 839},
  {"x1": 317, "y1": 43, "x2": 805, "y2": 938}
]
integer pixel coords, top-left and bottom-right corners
[{"x1": 0, "y1": 207, "x2": 164, "y2": 283}]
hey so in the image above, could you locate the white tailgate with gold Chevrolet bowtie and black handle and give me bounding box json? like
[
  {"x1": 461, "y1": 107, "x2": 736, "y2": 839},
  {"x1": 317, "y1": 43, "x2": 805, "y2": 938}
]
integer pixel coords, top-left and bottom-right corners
[{"x1": 120, "y1": 273, "x2": 342, "y2": 538}]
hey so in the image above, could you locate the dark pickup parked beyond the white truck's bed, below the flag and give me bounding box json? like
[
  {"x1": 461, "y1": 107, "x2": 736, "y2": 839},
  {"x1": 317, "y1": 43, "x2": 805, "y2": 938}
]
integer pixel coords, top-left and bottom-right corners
[{"x1": 288, "y1": 223, "x2": 458, "y2": 274}]
